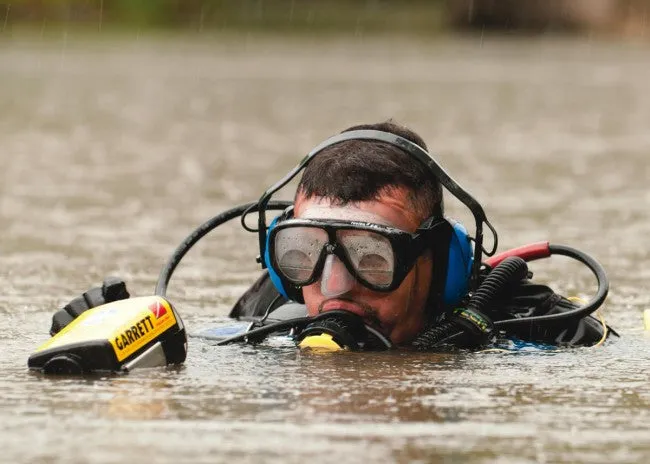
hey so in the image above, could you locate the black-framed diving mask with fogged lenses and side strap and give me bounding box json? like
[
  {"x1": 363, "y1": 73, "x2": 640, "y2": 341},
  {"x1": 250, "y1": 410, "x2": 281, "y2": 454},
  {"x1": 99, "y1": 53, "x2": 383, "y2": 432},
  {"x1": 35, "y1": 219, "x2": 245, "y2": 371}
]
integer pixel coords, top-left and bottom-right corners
[{"x1": 269, "y1": 218, "x2": 444, "y2": 295}]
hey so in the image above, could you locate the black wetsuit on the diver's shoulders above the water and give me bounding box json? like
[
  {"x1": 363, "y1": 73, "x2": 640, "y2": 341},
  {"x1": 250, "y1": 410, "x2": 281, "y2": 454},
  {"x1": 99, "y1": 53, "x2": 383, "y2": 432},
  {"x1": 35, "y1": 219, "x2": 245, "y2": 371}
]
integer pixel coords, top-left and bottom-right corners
[{"x1": 230, "y1": 272, "x2": 617, "y2": 346}]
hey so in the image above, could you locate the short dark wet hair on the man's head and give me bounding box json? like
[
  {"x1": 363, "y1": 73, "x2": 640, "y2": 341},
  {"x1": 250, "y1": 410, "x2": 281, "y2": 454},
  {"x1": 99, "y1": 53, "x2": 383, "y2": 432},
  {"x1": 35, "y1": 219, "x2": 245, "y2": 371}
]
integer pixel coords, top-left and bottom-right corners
[{"x1": 296, "y1": 121, "x2": 442, "y2": 220}]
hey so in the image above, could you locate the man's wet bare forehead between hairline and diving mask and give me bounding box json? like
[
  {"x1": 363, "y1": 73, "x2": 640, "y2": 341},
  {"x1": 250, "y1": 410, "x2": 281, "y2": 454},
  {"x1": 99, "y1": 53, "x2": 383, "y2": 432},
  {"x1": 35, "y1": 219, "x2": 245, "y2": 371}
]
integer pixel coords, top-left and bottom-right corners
[{"x1": 294, "y1": 189, "x2": 419, "y2": 232}]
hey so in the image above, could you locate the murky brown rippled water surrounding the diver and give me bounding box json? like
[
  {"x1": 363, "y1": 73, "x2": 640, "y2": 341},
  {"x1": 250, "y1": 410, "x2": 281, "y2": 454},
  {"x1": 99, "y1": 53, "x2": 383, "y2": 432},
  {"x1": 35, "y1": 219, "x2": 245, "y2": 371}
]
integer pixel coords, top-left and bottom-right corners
[{"x1": 0, "y1": 34, "x2": 650, "y2": 463}]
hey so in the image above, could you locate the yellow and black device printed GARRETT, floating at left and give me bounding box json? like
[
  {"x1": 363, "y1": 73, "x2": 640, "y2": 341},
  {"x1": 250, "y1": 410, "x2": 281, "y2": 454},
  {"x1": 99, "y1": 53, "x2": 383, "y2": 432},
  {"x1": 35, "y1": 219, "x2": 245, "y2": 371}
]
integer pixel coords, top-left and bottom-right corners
[{"x1": 27, "y1": 296, "x2": 187, "y2": 374}]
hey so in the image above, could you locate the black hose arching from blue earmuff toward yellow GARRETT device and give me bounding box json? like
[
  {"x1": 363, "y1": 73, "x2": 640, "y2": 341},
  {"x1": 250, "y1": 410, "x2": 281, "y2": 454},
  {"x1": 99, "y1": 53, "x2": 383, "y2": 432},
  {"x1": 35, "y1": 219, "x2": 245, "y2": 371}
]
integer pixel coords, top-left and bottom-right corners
[{"x1": 154, "y1": 201, "x2": 293, "y2": 297}]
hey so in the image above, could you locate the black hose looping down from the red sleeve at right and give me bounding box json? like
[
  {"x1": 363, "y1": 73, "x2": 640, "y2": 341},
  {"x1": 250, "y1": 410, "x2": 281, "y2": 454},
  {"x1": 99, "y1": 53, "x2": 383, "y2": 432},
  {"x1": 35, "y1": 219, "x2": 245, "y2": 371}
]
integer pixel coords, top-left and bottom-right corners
[{"x1": 494, "y1": 245, "x2": 609, "y2": 328}]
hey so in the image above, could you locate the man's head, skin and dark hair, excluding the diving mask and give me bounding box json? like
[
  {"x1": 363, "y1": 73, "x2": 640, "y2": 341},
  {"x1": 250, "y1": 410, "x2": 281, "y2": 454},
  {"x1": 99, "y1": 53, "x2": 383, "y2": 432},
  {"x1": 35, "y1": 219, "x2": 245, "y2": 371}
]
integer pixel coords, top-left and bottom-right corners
[{"x1": 294, "y1": 122, "x2": 442, "y2": 343}]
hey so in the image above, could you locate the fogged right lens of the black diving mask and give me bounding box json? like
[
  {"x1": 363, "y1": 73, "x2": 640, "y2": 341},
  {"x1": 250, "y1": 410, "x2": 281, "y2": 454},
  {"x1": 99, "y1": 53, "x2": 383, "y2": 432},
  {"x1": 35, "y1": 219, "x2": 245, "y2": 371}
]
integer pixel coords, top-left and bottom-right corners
[{"x1": 336, "y1": 229, "x2": 395, "y2": 287}]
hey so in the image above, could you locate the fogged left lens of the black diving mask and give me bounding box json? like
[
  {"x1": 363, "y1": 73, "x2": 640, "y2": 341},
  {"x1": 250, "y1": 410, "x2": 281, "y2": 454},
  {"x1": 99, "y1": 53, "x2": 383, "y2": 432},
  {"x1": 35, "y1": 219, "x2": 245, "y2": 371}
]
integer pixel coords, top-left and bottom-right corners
[{"x1": 273, "y1": 227, "x2": 327, "y2": 285}]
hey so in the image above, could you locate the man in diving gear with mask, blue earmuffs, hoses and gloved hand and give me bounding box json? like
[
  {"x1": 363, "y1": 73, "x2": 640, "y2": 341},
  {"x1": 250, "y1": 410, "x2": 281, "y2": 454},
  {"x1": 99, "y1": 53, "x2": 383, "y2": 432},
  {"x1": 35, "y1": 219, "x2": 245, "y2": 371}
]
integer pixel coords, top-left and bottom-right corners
[{"x1": 41, "y1": 121, "x2": 616, "y2": 368}]
